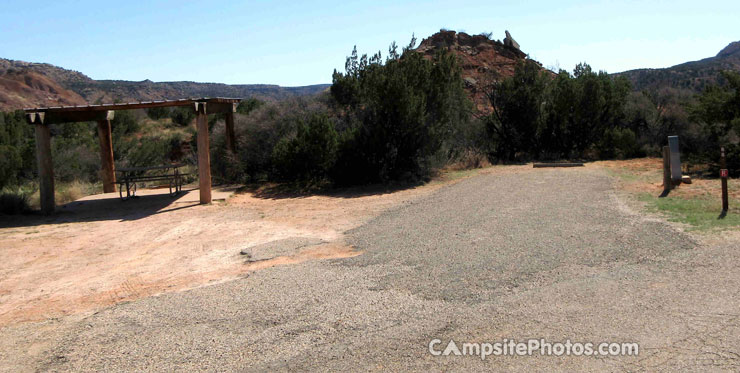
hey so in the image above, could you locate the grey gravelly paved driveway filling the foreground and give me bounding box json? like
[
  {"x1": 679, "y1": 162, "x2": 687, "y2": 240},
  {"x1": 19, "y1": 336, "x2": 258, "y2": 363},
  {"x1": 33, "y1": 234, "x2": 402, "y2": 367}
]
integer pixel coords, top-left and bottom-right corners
[{"x1": 8, "y1": 168, "x2": 740, "y2": 371}]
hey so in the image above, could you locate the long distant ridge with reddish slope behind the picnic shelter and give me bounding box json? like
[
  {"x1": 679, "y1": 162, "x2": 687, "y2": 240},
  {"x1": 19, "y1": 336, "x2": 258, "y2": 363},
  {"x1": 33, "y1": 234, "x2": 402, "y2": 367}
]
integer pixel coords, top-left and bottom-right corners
[{"x1": 0, "y1": 58, "x2": 329, "y2": 111}]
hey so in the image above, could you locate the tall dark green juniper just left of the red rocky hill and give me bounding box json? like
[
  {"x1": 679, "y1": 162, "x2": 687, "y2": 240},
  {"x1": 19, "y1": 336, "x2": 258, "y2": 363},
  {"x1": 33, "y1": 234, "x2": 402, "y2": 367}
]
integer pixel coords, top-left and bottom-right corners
[{"x1": 331, "y1": 40, "x2": 470, "y2": 184}]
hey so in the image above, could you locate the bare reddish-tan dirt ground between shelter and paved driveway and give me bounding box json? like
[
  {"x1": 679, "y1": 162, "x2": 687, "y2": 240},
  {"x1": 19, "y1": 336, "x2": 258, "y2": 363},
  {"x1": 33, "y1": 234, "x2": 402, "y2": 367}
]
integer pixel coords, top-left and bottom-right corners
[{"x1": 0, "y1": 167, "x2": 528, "y2": 327}]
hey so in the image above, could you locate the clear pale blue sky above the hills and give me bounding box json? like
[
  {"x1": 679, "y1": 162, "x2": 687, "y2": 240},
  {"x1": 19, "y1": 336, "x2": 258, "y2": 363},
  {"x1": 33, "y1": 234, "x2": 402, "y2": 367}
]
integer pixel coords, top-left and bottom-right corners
[{"x1": 0, "y1": 0, "x2": 740, "y2": 86}]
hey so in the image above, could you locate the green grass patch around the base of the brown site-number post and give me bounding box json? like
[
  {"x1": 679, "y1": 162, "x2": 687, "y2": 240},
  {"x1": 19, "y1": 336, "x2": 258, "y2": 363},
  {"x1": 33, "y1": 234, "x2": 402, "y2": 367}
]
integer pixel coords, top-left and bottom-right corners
[{"x1": 639, "y1": 193, "x2": 740, "y2": 231}]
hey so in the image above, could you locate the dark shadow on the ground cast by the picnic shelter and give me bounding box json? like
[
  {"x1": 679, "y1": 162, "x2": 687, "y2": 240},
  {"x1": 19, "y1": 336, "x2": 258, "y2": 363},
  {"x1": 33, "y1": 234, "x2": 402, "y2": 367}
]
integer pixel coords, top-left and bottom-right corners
[{"x1": 0, "y1": 189, "x2": 199, "y2": 228}]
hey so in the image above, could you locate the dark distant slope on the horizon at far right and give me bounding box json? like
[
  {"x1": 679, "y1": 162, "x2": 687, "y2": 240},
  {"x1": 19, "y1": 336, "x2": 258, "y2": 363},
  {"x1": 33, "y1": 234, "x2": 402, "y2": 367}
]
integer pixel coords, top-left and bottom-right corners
[{"x1": 615, "y1": 41, "x2": 740, "y2": 92}]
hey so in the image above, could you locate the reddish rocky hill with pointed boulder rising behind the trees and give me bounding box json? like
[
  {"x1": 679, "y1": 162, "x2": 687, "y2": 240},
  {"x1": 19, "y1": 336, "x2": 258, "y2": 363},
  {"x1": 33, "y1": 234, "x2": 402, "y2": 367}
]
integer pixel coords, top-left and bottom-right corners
[{"x1": 416, "y1": 30, "x2": 542, "y2": 113}]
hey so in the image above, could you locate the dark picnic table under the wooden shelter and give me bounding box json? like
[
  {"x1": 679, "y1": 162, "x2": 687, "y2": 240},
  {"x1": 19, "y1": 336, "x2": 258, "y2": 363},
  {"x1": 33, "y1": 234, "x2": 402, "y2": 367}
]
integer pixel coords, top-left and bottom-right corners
[{"x1": 116, "y1": 164, "x2": 187, "y2": 201}]
